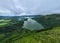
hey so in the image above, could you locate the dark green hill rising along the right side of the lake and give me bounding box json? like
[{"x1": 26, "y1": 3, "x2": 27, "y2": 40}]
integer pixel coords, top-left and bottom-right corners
[{"x1": 34, "y1": 14, "x2": 60, "y2": 28}]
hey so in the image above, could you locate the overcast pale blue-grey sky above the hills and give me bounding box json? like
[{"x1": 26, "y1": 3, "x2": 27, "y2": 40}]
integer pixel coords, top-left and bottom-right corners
[{"x1": 0, "y1": 0, "x2": 60, "y2": 16}]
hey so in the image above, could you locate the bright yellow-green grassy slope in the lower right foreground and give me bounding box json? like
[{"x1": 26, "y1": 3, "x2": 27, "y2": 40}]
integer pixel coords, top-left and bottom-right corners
[{"x1": 13, "y1": 27, "x2": 60, "y2": 43}]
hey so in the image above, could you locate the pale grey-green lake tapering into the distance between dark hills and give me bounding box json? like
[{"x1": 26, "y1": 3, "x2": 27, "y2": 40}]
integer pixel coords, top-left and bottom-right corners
[{"x1": 23, "y1": 18, "x2": 44, "y2": 30}]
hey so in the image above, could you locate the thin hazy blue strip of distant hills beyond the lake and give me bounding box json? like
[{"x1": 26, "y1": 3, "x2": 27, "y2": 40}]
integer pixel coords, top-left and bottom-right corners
[{"x1": 0, "y1": 15, "x2": 42, "y2": 19}]
